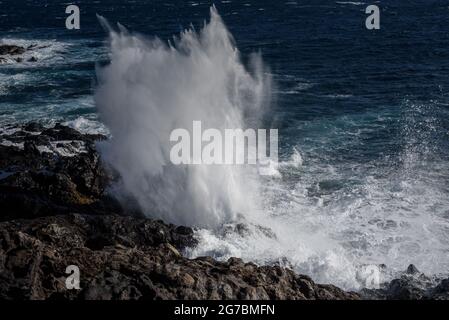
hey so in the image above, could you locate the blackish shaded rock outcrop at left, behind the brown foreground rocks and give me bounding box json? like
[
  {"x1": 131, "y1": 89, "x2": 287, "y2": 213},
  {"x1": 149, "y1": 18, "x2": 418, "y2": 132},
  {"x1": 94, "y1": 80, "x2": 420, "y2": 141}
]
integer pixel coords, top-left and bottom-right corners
[{"x1": 0, "y1": 123, "x2": 121, "y2": 220}]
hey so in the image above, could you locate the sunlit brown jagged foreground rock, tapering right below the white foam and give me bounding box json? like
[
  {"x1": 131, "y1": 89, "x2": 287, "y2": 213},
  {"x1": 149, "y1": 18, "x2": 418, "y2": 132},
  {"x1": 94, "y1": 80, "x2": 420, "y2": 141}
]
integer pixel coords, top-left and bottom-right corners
[{"x1": 0, "y1": 214, "x2": 358, "y2": 299}]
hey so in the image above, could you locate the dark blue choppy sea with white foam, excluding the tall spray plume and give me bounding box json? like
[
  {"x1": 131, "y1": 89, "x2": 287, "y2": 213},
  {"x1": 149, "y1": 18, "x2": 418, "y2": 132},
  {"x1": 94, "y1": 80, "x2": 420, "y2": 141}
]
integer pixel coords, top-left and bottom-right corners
[{"x1": 0, "y1": 0, "x2": 449, "y2": 289}]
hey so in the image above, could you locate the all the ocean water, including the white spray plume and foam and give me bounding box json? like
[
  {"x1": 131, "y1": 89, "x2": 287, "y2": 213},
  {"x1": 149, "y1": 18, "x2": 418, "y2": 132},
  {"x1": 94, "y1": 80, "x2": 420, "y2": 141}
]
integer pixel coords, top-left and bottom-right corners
[{"x1": 0, "y1": 0, "x2": 449, "y2": 289}]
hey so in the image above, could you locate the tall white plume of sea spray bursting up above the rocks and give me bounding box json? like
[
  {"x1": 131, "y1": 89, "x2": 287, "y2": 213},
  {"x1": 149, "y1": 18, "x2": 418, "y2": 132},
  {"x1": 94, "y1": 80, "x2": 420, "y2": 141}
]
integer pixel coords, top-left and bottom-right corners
[{"x1": 95, "y1": 7, "x2": 271, "y2": 228}]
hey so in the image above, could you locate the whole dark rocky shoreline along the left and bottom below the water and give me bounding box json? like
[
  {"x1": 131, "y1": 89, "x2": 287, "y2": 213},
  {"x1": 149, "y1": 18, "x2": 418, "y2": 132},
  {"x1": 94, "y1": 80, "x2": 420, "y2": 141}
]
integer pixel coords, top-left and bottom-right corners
[{"x1": 0, "y1": 123, "x2": 449, "y2": 300}]
